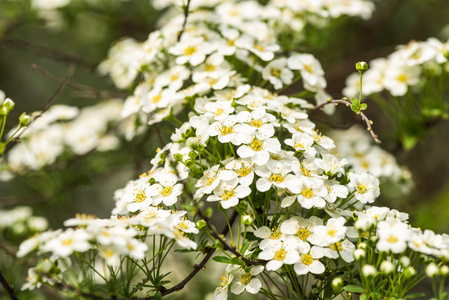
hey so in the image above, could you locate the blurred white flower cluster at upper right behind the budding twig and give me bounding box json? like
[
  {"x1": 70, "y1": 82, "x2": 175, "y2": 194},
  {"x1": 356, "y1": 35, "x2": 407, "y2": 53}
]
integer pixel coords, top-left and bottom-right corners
[{"x1": 343, "y1": 38, "x2": 449, "y2": 97}]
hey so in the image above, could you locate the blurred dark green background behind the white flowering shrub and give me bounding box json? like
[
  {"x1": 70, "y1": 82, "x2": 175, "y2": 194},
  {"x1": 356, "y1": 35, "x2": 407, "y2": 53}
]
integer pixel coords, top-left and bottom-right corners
[{"x1": 0, "y1": 0, "x2": 449, "y2": 299}]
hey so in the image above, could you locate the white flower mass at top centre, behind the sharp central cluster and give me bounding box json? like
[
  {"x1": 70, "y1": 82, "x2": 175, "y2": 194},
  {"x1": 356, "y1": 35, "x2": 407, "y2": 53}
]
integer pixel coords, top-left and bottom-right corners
[{"x1": 99, "y1": 0, "x2": 378, "y2": 129}]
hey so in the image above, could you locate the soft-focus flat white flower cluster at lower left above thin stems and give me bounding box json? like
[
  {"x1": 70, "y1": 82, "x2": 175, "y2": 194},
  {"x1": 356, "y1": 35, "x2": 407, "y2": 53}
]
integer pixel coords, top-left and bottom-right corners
[{"x1": 17, "y1": 206, "x2": 198, "y2": 267}]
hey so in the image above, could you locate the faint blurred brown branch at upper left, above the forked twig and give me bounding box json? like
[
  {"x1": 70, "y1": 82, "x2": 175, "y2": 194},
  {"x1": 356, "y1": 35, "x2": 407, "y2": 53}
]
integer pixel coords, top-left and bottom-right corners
[{"x1": 0, "y1": 38, "x2": 97, "y2": 73}]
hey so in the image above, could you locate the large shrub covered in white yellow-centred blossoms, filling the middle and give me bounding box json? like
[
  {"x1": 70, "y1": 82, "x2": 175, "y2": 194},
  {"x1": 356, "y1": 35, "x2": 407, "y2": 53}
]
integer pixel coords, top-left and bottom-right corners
[{"x1": 2, "y1": 0, "x2": 449, "y2": 300}]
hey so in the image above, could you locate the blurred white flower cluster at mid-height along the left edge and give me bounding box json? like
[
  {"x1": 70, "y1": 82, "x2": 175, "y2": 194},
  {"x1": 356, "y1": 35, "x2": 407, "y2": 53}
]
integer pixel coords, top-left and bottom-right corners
[{"x1": 7, "y1": 100, "x2": 121, "y2": 172}]
